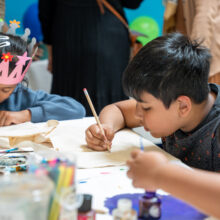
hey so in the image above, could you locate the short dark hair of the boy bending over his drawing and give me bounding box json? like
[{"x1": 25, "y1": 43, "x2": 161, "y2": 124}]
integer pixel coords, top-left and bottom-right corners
[{"x1": 122, "y1": 33, "x2": 211, "y2": 108}]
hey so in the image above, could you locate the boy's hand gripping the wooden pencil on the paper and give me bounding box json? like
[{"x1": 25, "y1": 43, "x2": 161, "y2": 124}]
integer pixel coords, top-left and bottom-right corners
[{"x1": 86, "y1": 124, "x2": 115, "y2": 151}]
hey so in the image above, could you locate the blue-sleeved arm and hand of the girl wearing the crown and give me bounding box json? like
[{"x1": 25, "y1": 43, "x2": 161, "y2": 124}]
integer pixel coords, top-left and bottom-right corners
[{"x1": 0, "y1": 85, "x2": 85, "y2": 126}]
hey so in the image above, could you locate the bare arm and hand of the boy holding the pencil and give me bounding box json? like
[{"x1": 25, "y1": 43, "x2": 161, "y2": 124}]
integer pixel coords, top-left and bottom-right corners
[{"x1": 86, "y1": 99, "x2": 141, "y2": 151}]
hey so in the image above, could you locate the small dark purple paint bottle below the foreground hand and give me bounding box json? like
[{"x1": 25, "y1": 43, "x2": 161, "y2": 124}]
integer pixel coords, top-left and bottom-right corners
[{"x1": 138, "y1": 191, "x2": 161, "y2": 220}]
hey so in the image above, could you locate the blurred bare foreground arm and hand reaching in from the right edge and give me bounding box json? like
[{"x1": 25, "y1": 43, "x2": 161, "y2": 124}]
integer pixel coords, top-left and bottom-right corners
[{"x1": 127, "y1": 151, "x2": 220, "y2": 218}]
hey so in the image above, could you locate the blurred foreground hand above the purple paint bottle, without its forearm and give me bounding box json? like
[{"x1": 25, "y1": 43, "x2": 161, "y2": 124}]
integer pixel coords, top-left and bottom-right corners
[{"x1": 127, "y1": 150, "x2": 167, "y2": 190}]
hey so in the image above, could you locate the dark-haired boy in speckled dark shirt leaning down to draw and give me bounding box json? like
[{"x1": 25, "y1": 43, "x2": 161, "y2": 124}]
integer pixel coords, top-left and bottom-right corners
[{"x1": 86, "y1": 33, "x2": 220, "y2": 171}]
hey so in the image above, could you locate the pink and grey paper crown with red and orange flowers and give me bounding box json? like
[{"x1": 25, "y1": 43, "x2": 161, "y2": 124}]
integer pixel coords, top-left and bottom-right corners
[{"x1": 0, "y1": 20, "x2": 36, "y2": 85}]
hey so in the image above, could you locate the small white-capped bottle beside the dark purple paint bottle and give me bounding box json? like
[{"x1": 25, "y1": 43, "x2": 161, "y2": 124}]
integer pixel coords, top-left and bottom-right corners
[{"x1": 112, "y1": 199, "x2": 137, "y2": 220}]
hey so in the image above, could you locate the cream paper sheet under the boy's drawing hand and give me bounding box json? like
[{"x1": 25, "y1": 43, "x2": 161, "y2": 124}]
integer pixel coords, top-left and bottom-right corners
[{"x1": 50, "y1": 120, "x2": 178, "y2": 168}]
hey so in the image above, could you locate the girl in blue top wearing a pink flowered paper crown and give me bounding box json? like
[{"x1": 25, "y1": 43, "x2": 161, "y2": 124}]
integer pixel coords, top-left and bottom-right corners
[{"x1": 0, "y1": 20, "x2": 85, "y2": 126}]
